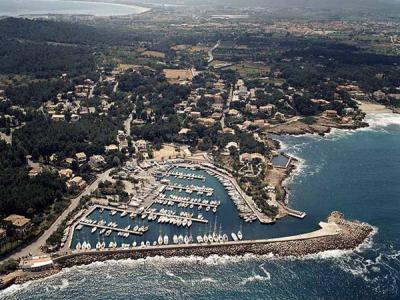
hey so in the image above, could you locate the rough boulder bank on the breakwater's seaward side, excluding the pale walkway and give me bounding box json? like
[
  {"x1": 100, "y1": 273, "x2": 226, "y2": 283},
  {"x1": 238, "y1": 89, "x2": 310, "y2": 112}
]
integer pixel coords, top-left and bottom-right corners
[{"x1": 54, "y1": 212, "x2": 373, "y2": 268}]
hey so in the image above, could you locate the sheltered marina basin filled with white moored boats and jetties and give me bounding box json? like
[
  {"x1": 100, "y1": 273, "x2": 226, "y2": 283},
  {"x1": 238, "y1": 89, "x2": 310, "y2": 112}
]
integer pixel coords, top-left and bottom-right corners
[{"x1": 69, "y1": 161, "x2": 306, "y2": 251}]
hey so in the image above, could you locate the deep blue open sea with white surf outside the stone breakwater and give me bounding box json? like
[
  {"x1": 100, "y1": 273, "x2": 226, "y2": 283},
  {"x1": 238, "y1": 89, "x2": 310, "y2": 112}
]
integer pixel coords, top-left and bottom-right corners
[{"x1": 0, "y1": 114, "x2": 400, "y2": 300}]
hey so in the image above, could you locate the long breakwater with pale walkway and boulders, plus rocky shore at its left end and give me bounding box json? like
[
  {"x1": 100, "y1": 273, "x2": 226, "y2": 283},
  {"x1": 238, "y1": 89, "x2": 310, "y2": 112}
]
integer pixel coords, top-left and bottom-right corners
[{"x1": 4, "y1": 212, "x2": 376, "y2": 289}]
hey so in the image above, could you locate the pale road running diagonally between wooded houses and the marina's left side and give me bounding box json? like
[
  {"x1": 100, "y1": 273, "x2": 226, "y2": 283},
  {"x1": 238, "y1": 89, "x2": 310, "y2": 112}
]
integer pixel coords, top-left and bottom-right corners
[{"x1": 10, "y1": 169, "x2": 113, "y2": 259}]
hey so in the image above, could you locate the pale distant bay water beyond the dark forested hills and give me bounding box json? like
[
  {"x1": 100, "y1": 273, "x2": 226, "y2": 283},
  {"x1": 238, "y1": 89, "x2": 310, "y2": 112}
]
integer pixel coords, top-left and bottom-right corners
[{"x1": 0, "y1": 0, "x2": 148, "y2": 17}]
